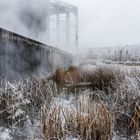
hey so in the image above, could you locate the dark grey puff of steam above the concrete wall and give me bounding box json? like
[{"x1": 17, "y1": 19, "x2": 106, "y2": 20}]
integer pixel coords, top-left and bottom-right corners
[{"x1": 19, "y1": 0, "x2": 48, "y2": 37}]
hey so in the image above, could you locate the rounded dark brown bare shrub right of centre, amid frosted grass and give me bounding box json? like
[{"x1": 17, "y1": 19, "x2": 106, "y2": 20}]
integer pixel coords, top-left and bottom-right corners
[{"x1": 88, "y1": 67, "x2": 123, "y2": 93}]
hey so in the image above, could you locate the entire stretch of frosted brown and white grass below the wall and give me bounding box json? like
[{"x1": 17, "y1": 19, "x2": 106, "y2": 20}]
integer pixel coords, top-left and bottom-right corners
[{"x1": 0, "y1": 66, "x2": 140, "y2": 140}]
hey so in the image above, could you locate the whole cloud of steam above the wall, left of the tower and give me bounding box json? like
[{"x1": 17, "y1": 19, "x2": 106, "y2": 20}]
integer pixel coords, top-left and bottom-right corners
[{"x1": 0, "y1": 0, "x2": 48, "y2": 41}]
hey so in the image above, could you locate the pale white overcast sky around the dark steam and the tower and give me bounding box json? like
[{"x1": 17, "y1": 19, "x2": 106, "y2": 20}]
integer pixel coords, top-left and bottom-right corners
[{"x1": 0, "y1": 0, "x2": 140, "y2": 48}]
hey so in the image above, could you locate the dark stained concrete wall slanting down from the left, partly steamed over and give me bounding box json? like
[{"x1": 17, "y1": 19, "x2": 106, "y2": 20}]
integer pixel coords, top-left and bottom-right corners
[{"x1": 0, "y1": 29, "x2": 72, "y2": 80}]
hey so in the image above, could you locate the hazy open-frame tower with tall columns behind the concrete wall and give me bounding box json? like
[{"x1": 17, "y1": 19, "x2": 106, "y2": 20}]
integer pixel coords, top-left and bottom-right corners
[{"x1": 47, "y1": 0, "x2": 78, "y2": 46}]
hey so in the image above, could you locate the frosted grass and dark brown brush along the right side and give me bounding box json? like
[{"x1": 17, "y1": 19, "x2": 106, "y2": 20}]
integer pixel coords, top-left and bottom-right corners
[{"x1": 52, "y1": 66, "x2": 140, "y2": 137}]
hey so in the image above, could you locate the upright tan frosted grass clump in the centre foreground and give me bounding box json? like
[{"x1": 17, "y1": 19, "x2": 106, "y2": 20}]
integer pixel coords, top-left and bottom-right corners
[{"x1": 41, "y1": 101, "x2": 112, "y2": 140}]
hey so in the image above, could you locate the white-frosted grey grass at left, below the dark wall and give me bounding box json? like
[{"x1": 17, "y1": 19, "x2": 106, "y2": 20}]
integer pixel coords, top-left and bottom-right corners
[{"x1": 0, "y1": 77, "x2": 55, "y2": 127}]
